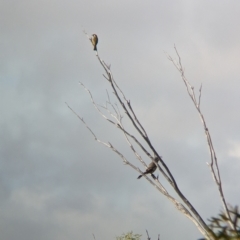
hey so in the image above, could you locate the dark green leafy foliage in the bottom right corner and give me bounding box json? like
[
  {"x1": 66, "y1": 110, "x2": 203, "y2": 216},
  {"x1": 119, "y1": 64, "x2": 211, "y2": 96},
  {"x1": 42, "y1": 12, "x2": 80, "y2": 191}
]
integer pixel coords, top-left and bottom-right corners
[{"x1": 208, "y1": 206, "x2": 240, "y2": 240}]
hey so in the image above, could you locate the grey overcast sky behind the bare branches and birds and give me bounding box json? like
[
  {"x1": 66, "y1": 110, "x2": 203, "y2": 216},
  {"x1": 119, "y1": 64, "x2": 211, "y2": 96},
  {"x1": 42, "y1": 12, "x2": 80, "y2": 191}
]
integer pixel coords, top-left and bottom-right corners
[{"x1": 0, "y1": 0, "x2": 240, "y2": 240}]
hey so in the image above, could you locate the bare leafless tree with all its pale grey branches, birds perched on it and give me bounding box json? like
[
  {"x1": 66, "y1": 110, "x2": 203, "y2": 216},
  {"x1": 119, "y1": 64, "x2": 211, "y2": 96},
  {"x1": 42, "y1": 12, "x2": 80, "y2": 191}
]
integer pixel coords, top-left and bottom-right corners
[{"x1": 66, "y1": 32, "x2": 234, "y2": 239}]
